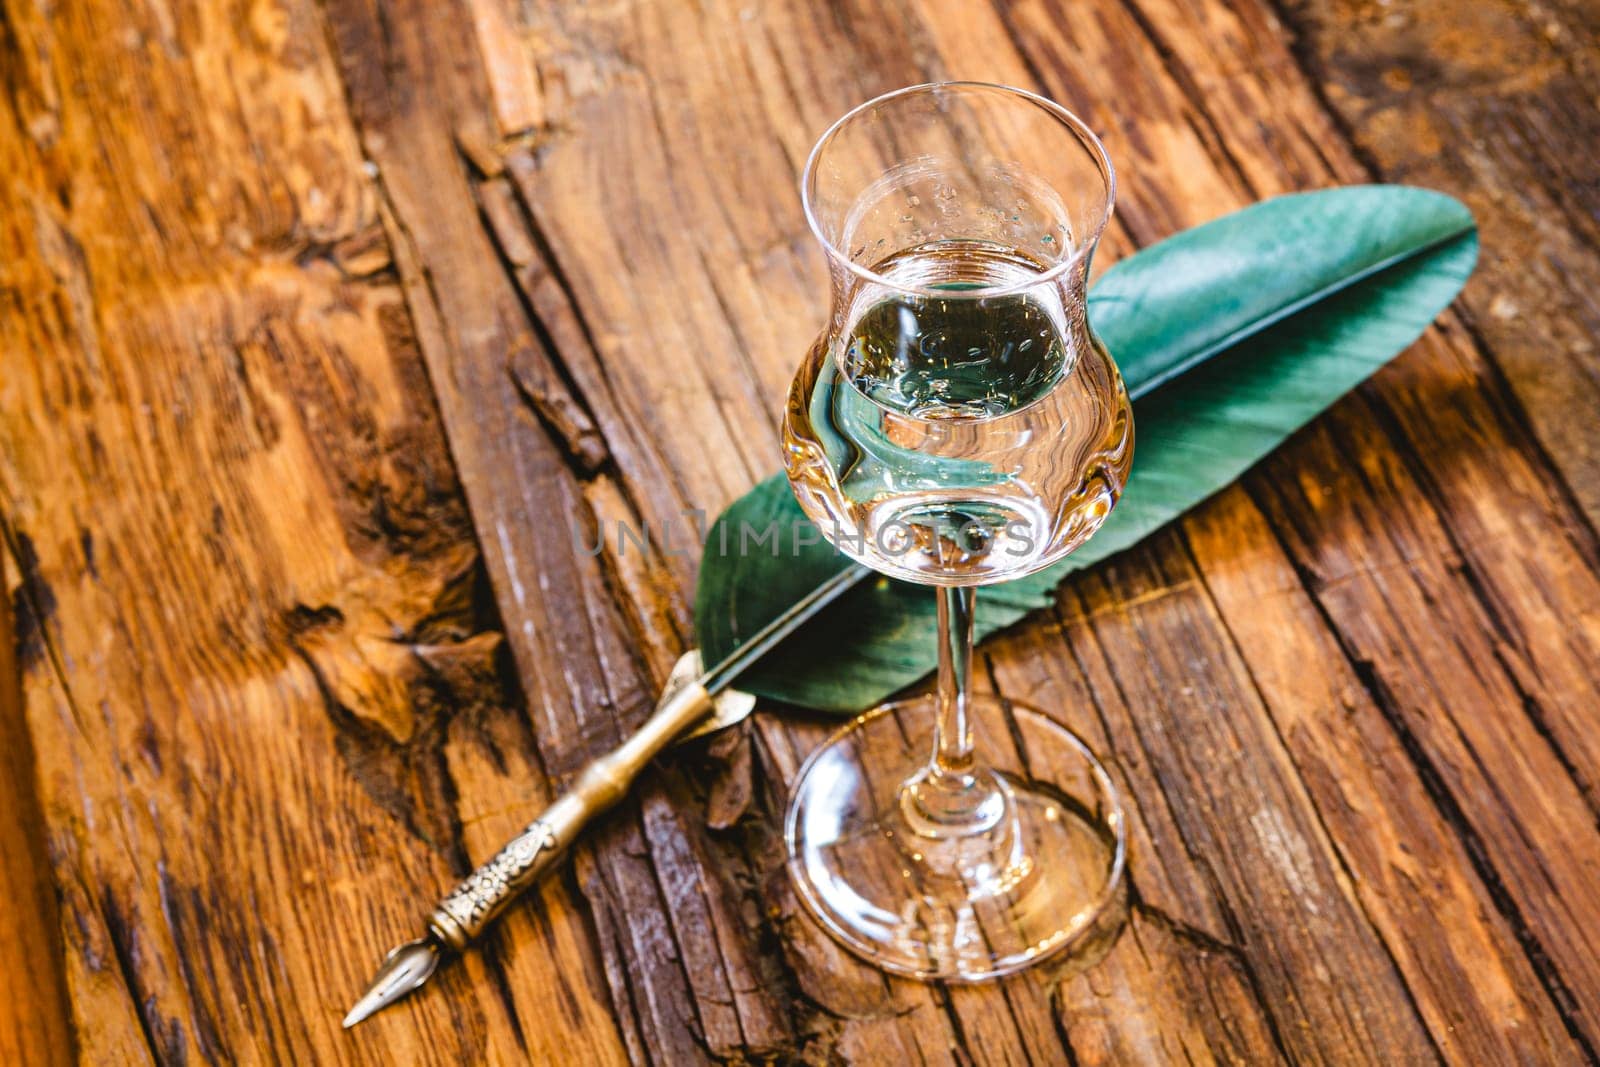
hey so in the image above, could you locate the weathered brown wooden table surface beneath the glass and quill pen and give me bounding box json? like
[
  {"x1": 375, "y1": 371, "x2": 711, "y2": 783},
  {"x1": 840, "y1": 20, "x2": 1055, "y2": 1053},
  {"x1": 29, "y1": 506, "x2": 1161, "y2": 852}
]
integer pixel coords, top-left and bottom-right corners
[{"x1": 0, "y1": 0, "x2": 1600, "y2": 1065}]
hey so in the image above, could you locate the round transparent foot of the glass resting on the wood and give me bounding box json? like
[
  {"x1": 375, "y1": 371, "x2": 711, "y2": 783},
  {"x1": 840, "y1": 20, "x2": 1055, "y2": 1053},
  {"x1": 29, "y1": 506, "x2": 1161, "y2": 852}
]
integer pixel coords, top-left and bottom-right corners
[{"x1": 784, "y1": 694, "x2": 1126, "y2": 982}]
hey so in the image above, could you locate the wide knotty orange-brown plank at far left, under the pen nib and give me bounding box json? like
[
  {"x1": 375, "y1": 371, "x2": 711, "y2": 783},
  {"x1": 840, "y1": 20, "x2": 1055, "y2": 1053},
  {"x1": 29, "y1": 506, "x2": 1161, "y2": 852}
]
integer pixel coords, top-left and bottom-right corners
[{"x1": 0, "y1": 3, "x2": 626, "y2": 1064}]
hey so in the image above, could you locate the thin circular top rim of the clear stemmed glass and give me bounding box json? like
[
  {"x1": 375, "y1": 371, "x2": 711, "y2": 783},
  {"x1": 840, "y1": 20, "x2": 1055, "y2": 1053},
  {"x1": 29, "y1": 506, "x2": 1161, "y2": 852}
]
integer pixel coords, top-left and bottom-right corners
[{"x1": 800, "y1": 80, "x2": 1117, "y2": 299}]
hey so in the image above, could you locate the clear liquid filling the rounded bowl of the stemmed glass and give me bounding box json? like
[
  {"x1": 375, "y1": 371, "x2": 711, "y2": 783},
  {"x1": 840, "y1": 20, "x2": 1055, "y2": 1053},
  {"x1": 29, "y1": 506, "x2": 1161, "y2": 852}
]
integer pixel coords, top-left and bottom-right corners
[{"x1": 784, "y1": 242, "x2": 1133, "y2": 585}]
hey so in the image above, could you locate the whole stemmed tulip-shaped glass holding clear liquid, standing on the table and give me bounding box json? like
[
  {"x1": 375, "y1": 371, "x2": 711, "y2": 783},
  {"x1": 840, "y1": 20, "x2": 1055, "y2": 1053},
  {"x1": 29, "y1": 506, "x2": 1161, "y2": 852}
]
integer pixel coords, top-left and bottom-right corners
[{"x1": 782, "y1": 82, "x2": 1133, "y2": 981}]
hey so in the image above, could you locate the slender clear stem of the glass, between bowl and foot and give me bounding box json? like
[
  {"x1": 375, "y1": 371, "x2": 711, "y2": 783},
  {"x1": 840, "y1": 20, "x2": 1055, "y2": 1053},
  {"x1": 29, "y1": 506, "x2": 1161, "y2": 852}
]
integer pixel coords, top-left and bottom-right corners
[{"x1": 901, "y1": 585, "x2": 1006, "y2": 838}]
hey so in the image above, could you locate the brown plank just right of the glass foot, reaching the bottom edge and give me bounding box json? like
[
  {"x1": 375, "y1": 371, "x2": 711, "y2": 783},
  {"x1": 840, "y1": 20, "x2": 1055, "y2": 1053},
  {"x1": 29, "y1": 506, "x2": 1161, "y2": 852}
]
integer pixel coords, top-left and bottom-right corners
[{"x1": 1069, "y1": 550, "x2": 1435, "y2": 1062}]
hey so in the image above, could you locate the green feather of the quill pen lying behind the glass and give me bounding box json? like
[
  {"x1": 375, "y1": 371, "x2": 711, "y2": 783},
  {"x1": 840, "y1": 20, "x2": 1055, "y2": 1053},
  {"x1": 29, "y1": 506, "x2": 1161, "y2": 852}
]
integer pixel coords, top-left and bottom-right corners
[{"x1": 694, "y1": 186, "x2": 1478, "y2": 713}]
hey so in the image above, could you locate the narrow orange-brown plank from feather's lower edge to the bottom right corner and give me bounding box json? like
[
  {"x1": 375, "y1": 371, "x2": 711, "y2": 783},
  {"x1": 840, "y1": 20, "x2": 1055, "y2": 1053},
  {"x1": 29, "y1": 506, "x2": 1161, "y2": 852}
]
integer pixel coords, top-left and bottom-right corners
[{"x1": 1184, "y1": 493, "x2": 1579, "y2": 1062}]
